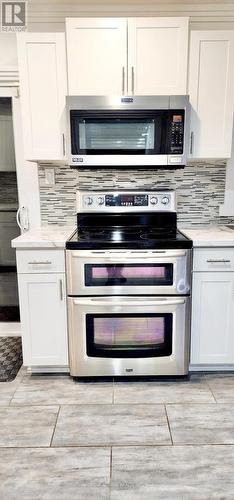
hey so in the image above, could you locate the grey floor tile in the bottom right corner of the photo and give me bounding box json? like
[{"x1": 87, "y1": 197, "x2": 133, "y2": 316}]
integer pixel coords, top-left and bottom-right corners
[{"x1": 111, "y1": 446, "x2": 234, "y2": 500}]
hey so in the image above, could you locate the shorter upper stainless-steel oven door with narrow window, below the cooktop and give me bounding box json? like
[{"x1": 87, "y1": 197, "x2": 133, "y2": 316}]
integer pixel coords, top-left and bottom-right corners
[{"x1": 66, "y1": 250, "x2": 190, "y2": 296}]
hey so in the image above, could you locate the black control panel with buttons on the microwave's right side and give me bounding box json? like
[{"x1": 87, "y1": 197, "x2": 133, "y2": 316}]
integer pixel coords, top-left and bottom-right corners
[{"x1": 168, "y1": 110, "x2": 184, "y2": 154}]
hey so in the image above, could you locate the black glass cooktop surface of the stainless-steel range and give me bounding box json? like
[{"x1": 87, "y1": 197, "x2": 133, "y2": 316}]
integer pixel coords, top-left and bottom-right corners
[{"x1": 66, "y1": 227, "x2": 192, "y2": 249}]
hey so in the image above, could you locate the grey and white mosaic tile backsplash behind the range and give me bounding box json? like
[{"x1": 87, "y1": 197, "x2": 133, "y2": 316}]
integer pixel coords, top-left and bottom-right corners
[{"x1": 38, "y1": 161, "x2": 233, "y2": 227}]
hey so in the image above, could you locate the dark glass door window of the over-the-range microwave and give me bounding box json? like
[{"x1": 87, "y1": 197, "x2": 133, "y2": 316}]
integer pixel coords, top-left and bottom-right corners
[{"x1": 70, "y1": 111, "x2": 167, "y2": 155}]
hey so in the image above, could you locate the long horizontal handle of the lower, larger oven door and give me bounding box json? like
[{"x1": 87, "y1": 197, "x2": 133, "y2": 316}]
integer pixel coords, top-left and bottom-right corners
[{"x1": 73, "y1": 297, "x2": 185, "y2": 306}]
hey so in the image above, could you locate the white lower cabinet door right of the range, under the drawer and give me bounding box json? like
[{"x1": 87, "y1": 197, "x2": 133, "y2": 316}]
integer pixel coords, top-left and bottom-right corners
[{"x1": 191, "y1": 272, "x2": 234, "y2": 364}]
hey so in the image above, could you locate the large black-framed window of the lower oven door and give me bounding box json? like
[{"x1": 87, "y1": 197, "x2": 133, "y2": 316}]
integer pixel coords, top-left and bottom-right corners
[{"x1": 86, "y1": 313, "x2": 173, "y2": 358}]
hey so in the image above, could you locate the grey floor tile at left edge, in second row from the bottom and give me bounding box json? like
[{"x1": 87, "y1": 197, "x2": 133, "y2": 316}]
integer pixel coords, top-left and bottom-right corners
[{"x1": 0, "y1": 406, "x2": 59, "y2": 448}]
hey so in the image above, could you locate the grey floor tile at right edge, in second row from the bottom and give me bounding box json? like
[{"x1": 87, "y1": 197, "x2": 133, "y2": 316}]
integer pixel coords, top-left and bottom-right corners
[{"x1": 167, "y1": 404, "x2": 234, "y2": 444}]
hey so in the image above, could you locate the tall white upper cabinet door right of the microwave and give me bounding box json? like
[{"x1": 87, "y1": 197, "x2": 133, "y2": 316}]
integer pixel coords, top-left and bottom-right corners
[{"x1": 188, "y1": 31, "x2": 234, "y2": 158}]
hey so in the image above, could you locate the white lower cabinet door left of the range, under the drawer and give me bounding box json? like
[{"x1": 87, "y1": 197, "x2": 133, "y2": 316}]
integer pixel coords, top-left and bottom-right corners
[{"x1": 18, "y1": 274, "x2": 68, "y2": 366}]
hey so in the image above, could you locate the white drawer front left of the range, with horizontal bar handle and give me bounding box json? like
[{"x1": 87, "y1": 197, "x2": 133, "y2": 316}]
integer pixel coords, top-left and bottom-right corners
[{"x1": 16, "y1": 250, "x2": 65, "y2": 273}]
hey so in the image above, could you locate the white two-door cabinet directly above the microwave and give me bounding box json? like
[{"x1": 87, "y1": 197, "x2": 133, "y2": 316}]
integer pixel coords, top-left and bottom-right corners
[{"x1": 66, "y1": 17, "x2": 188, "y2": 95}]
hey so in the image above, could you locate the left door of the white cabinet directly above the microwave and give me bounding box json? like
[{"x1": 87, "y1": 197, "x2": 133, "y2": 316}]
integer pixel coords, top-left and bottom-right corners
[{"x1": 66, "y1": 18, "x2": 127, "y2": 95}]
